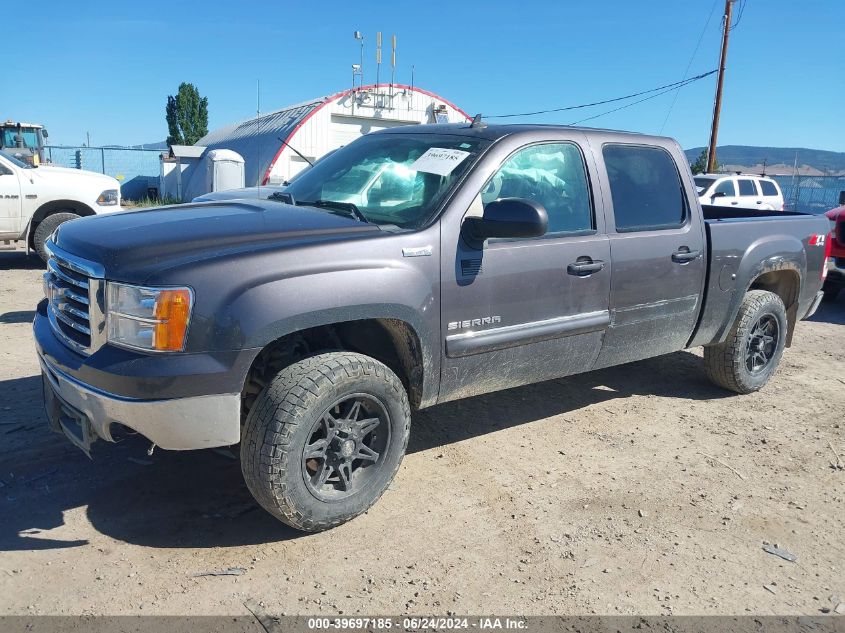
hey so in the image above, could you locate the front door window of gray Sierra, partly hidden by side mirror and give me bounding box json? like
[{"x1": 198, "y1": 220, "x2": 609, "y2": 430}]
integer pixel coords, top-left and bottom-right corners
[{"x1": 481, "y1": 143, "x2": 595, "y2": 235}]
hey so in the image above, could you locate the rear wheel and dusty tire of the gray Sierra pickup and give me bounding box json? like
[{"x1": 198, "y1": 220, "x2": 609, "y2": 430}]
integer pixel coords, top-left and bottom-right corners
[{"x1": 704, "y1": 290, "x2": 788, "y2": 394}]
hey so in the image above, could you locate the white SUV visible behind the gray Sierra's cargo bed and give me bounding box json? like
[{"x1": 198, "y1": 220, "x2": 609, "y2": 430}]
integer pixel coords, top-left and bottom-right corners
[{"x1": 695, "y1": 174, "x2": 783, "y2": 211}]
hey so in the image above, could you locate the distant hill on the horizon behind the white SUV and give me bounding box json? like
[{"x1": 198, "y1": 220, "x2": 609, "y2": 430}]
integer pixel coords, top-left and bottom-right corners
[{"x1": 685, "y1": 145, "x2": 845, "y2": 176}]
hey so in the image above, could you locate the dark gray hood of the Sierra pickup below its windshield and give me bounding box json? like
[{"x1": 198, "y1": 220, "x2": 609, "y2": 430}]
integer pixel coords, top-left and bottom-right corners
[{"x1": 54, "y1": 200, "x2": 381, "y2": 283}]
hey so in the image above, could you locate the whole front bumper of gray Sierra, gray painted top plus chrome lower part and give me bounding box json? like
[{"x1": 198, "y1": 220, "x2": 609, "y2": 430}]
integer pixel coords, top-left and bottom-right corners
[{"x1": 33, "y1": 301, "x2": 252, "y2": 452}]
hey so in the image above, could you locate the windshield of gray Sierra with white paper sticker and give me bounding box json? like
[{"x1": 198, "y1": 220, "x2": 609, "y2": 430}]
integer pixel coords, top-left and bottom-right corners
[{"x1": 284, "y1": 134, "x2": 489, "y2": 229}]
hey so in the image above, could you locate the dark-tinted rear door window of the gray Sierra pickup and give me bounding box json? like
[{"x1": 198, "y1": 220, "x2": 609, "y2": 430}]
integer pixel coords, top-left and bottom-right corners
[{"x1": 602, "y1": 145, "x2": 687, "y2": 232}]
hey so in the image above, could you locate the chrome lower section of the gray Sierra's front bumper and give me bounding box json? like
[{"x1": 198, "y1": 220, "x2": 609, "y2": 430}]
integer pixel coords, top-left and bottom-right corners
[{"x1": 39, "y1": 355, "x2": 241, "y2": 453}]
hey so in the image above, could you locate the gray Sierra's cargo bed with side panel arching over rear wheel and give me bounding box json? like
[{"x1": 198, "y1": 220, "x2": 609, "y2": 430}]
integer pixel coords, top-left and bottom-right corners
[{"x1": 690, "y1": 205, "x2": 829, "y2": 346}]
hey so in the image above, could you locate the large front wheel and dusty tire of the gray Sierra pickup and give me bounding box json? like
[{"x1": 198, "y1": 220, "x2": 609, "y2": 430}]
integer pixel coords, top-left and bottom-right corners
[{"x1": 241, "y1": 352, "x2": 411, "y2": 532}]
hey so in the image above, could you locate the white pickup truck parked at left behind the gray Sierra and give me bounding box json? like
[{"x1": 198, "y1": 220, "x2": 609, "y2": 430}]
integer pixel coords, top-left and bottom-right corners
[{"x1": 0, "y1": 151, "x2": 122, "y2": 261}]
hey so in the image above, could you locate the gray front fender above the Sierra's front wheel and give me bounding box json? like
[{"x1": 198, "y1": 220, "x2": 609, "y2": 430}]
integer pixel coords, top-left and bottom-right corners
[{"x1": 173, "y1": 234, "x2": 440, "y2": 399}]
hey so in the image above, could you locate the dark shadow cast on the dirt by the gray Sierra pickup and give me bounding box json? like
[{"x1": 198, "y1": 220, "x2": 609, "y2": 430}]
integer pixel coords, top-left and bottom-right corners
[{"x1": 0, "y1": 352, "x2": 728, "y2": 551}]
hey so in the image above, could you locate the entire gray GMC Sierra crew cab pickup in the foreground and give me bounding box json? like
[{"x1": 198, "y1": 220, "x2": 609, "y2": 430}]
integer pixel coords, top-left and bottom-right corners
[{"x1": 33, "y1": 123, "x2": 828, "y2": 531}]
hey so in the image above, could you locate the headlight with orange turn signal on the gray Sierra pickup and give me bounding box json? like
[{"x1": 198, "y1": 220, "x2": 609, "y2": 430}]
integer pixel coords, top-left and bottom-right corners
[{"x1": 106, "y1": 282, "x2": 193, "y2": 352}]
